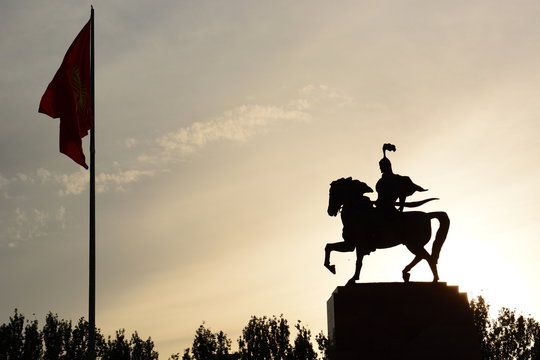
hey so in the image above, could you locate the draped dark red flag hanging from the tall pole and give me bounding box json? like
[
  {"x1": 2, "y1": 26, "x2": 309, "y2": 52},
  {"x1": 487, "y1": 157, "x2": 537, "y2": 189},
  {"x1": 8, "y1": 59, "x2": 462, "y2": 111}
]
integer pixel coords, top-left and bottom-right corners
[{"x1": 39, "y1": 21, "x2": 94, "y2": 169}]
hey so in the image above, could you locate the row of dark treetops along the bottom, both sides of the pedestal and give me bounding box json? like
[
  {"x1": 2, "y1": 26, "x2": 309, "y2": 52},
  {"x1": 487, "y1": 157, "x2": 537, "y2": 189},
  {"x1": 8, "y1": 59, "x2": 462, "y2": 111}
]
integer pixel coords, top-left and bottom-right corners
[{"x1": 4, "y1": 296, "x2": 540, "y2": 360}]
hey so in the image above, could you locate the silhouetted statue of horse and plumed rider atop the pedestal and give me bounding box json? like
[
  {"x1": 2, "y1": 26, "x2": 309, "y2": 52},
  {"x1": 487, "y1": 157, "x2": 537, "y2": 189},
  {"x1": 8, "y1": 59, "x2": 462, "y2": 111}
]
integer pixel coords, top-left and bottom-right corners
[{"x1": 324, "y1": 144, "x2": 450, "y2": 285}]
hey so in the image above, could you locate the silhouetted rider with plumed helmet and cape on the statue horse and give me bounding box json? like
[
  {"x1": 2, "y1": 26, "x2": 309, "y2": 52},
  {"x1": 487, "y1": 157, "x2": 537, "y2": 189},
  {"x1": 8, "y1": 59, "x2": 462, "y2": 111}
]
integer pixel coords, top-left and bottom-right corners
[{"x1": 375, "y1": 144, "x2": 426, "y2": 219}]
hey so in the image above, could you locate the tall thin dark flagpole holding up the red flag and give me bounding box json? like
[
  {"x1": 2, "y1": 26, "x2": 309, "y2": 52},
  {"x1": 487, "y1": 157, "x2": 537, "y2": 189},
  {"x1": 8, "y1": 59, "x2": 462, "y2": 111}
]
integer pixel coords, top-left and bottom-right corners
[{"x1": 88, "y1": 6, "x2": 96, "y2": 360}]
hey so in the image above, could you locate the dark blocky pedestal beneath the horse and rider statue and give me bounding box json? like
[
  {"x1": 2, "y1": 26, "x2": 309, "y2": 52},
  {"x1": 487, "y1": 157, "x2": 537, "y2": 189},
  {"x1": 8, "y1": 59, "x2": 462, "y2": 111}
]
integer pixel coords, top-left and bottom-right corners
[{"x1": 327, "y1": 283, "x2": 480, "y2": 360}]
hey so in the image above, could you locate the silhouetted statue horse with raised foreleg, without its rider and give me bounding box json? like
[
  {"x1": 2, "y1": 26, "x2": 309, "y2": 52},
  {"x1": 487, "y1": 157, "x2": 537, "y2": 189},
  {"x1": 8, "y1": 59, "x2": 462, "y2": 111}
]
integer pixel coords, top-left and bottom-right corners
[{"x1": 324, "y1": 177, "x2": 450, "y2": 285}]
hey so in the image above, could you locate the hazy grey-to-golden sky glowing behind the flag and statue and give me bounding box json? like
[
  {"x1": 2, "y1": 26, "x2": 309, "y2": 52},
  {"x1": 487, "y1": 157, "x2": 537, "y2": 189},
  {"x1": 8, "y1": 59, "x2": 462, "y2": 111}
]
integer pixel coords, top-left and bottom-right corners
[{"x1": 0, "y1": 0, "x2": 540, "y2": 358}]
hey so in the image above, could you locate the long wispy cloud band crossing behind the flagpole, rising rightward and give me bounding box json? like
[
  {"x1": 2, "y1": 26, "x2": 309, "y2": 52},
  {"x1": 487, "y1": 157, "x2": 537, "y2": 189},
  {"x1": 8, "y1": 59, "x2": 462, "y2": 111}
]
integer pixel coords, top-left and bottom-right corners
[{"x1": 0, "y1": 84, "x2": 344, "y2": 198}]
